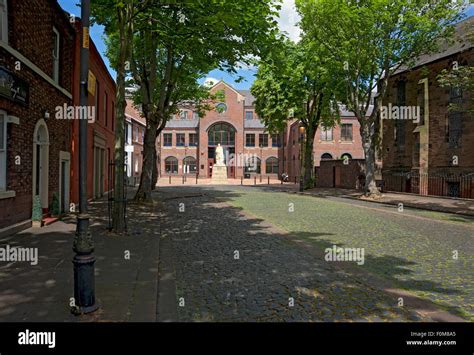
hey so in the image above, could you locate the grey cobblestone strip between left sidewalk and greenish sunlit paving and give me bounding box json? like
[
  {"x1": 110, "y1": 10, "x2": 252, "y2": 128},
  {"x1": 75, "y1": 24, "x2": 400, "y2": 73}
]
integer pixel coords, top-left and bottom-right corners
[{"x1": 160, "y1": 187, "x2": 458, "y2": 321}]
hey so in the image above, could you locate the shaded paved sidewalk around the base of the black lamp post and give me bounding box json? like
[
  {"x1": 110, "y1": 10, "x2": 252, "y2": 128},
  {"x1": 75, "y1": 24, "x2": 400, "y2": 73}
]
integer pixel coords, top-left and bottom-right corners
[{"x1": 0, "y1": 191, "x2": 160, "y2": 322}]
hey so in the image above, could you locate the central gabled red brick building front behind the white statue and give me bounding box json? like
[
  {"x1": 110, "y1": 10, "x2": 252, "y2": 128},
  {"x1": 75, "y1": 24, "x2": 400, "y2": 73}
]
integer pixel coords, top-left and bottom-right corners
[{"x1": 157, "y1": 81, "x2": 281, "y2": 178}]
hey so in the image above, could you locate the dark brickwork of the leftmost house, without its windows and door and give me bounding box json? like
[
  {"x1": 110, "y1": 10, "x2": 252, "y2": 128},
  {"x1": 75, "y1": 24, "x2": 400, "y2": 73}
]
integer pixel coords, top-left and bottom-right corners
[{"x1": 0, "y1": 0, "x2": 74, "y2": 228}]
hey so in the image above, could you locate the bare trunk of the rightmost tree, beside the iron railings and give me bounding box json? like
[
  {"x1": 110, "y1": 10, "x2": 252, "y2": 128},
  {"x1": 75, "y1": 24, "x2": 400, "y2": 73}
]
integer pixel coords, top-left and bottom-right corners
[{"x1": 359, "y1": 120, "x2": 380, "y2": 197}]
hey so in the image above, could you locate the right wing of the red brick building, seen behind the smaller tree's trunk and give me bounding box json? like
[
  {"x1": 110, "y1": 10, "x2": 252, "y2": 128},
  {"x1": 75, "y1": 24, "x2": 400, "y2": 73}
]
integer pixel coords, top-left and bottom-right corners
[{"x1": 283, "y1": 106, "x2": 370, "y2": 181}]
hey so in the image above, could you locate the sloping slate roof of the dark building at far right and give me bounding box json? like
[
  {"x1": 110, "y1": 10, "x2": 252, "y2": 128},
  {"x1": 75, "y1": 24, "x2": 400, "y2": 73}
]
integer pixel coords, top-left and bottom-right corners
[{"x1": 394, "y1": 16, "x2": 474, "y2": 75}]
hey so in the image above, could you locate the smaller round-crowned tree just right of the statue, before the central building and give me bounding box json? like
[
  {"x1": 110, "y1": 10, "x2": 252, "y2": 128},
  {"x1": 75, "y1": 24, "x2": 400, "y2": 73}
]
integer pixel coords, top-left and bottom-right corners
[{"x1": 251, "y1": 39, "x2": 343, "y2": 187}]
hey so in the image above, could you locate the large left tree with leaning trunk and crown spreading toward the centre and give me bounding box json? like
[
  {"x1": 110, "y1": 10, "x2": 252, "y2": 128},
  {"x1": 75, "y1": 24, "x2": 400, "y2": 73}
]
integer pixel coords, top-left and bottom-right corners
[{"x1": 123, "y1": 0, "x2": 278, "y2": 201}]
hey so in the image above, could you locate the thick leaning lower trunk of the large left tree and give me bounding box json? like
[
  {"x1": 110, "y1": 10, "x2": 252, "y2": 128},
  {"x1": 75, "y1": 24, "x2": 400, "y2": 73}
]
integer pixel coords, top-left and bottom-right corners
[{"x1": 135, "y1": 117, "x2": 158, "y2": 202}]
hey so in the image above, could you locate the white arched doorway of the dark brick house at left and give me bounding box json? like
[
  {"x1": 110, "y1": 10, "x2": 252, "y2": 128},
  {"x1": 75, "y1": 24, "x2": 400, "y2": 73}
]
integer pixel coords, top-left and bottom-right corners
[{"x1": 32, "y1": 119, "x2": 49, "y2": 210}]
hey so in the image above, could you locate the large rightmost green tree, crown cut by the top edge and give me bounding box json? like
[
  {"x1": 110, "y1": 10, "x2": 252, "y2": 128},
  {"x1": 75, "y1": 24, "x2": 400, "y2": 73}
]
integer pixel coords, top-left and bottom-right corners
[{"x1": 296, "y1": 0, "x2": 466, "y2": 195}]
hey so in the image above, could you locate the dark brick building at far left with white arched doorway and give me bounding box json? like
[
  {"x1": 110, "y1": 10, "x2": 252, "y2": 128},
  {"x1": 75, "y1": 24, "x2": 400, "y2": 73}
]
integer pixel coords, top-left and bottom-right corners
[{"x1": 0, "y1": 0, "x2": 75, "y2": 232}]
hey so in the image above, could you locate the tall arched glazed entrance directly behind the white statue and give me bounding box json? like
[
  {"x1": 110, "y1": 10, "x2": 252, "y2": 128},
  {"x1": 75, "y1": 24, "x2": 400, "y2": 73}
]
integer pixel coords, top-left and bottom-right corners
[{"x1": 207, "y1": 122, "x2": 236, "y2": 178}]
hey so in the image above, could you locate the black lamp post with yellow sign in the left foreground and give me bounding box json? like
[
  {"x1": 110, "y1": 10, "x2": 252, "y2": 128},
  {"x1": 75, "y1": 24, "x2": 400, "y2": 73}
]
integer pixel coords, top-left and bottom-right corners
[{"x1": 72, "y1": 0, "x2": 99, "y2": 314}]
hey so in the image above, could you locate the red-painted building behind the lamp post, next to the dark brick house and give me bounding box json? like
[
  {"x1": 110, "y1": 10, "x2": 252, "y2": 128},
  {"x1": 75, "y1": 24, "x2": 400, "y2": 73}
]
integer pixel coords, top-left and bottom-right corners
[{"x1": 71, "y1": 20, "x2": 116, "y2": 203}]
